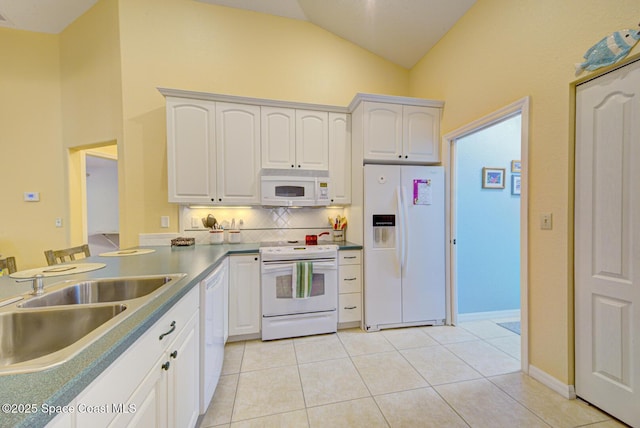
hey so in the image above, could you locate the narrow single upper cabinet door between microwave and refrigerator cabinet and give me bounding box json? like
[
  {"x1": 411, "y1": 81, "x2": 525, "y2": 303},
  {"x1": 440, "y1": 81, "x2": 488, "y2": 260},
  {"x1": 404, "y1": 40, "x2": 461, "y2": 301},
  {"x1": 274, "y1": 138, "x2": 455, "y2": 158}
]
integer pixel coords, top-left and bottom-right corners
[{"x1": 329, "y1": 113, "x2": 351, "y2": 204}]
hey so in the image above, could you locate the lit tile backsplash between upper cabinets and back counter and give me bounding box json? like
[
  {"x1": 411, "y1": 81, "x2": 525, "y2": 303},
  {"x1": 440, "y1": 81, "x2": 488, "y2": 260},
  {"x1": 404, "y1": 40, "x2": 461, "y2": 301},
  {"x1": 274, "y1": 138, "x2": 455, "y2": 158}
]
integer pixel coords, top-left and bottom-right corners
[{"x1": 180, "y1": 206, "x2": 344, "y2": 244}]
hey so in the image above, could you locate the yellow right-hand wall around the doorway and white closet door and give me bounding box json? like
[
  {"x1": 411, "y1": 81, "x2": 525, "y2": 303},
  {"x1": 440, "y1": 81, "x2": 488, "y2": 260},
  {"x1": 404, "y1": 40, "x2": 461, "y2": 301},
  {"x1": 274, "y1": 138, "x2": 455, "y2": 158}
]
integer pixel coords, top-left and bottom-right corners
[{"x1": 410, "y1": 0, "x2": 640, "y2": 384}]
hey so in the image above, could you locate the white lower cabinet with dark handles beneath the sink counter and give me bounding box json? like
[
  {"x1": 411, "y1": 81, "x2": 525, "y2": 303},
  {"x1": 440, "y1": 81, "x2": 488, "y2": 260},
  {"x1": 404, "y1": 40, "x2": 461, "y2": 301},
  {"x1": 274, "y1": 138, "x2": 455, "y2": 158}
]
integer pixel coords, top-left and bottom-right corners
[{"x1": 65, "y1": 287, "x2": 200, "y2": 428}]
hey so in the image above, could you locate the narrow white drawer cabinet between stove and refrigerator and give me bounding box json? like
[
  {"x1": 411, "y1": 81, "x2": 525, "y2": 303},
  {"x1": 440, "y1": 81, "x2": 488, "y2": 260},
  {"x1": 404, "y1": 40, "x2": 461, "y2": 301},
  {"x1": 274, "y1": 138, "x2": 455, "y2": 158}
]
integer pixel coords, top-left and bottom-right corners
[{"x1": 338, "y1": 250, "x2": 362, "y2": 325}]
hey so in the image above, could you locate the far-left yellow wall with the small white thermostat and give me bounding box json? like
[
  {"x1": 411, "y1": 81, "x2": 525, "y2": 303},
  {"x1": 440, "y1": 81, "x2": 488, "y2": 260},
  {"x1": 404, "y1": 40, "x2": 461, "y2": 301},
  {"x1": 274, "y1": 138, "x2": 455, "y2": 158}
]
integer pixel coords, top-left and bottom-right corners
[{"x1": 0, "y1": 28, "x2": 67, "y2": 269}]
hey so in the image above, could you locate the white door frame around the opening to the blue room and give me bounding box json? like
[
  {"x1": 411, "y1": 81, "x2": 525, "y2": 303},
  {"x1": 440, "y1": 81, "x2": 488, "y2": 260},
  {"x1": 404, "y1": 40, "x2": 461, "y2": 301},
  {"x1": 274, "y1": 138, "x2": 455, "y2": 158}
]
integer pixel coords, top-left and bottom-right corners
[{"x1": 442, "y1": 96, "x2": 530, "y2": 373}]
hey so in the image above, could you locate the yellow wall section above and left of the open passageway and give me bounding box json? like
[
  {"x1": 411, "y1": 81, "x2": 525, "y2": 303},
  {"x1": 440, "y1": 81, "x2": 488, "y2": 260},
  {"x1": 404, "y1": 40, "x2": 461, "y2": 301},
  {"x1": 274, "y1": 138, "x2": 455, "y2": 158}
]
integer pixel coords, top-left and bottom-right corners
[{"x1": 60, "y1": 0, "x2": 122, "y2": 251}]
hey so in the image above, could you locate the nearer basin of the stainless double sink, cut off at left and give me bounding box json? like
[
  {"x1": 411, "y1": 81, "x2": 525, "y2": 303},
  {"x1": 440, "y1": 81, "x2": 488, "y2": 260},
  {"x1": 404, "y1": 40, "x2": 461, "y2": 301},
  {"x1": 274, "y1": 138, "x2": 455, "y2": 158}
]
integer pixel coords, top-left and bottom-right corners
[{"x1": 0, "y1": 304, "x2": 127, "y2": 367}]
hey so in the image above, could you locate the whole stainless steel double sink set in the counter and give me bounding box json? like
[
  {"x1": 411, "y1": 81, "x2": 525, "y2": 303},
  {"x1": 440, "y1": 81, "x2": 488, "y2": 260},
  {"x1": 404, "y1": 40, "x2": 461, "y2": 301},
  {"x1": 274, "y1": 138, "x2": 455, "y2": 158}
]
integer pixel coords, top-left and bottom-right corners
[{"x1": 0, "y1": 274, "x2": 186, "y2": 374}]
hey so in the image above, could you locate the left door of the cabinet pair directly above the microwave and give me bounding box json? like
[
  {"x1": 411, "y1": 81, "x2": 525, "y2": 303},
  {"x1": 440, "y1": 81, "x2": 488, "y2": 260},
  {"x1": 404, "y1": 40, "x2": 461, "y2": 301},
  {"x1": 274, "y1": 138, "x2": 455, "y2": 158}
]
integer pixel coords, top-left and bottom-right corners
[{"x1": 260, "y1": 107, "x2": 296, "y2": 169}]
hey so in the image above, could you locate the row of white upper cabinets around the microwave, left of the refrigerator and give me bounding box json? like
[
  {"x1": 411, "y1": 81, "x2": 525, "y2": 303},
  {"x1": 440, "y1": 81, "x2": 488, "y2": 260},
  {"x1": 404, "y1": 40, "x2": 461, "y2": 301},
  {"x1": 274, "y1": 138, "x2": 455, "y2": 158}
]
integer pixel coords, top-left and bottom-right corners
[{"x1": 158, "y1": 88, "x2": 350, "y2": 206}]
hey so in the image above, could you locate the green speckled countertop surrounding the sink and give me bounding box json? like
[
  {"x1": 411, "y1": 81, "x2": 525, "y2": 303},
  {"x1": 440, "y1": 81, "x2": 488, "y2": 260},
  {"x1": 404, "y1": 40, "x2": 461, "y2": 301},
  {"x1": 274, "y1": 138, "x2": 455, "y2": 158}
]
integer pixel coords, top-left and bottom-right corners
[{"x1": 0, "y1": 242, "x2": 362, "y2": 427}]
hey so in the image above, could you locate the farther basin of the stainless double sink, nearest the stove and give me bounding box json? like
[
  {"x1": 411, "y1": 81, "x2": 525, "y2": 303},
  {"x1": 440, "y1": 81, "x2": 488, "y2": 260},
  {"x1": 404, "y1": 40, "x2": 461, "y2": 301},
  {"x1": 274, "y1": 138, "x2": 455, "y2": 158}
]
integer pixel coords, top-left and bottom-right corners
[{"x1": 18, "y1": 274, "x2": 184, "y2": 308}]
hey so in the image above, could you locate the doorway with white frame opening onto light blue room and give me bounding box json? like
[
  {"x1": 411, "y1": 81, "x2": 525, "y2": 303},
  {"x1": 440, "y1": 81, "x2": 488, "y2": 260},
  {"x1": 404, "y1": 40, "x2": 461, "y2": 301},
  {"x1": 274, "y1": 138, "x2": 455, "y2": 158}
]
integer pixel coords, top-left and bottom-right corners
[{"x1": 443, "y1": 97, "x2": 529, "y2": 373}]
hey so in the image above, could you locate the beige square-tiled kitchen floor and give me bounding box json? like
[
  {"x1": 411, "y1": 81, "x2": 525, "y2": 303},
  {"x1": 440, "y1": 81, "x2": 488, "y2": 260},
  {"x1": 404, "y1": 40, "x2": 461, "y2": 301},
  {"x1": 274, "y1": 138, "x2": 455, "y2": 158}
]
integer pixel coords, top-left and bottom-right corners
[{"x1": 200, "y1": 320, "x2": 625, "y2": 428}]
